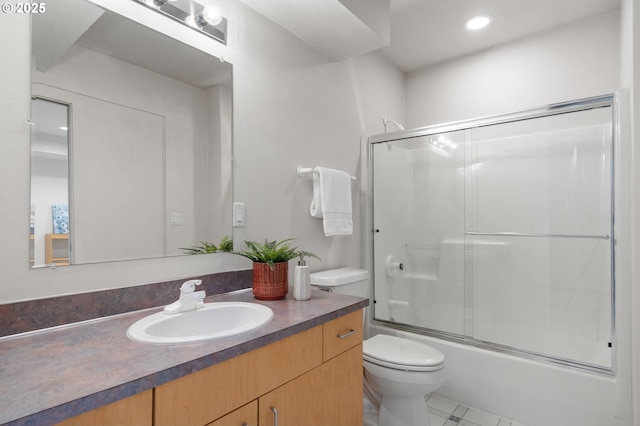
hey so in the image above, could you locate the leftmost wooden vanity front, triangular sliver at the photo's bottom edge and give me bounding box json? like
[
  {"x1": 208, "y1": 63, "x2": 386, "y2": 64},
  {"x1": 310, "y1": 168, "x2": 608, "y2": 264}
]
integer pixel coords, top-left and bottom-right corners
[{"x1": 58, "y1": 390, "x2": 153, "y2": 426}]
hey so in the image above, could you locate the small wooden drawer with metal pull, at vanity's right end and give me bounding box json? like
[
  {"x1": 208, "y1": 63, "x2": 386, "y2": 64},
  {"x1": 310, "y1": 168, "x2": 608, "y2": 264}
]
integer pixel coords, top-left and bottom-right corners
[{"x1": 322, "y1": 309, "x2": 363, "y2": 361}]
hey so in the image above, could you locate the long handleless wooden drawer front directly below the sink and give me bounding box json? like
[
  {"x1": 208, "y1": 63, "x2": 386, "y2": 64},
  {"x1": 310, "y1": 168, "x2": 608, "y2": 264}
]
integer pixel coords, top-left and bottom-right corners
[{"x1": 154, "y1": 326, "x2": 322, "y2": 426}]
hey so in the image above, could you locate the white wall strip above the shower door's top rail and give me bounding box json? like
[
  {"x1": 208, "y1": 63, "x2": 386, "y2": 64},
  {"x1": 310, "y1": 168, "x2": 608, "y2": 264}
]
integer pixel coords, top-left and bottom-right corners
[{"x1": 406, "y1": 12, "x2": 620, "y2": 128}]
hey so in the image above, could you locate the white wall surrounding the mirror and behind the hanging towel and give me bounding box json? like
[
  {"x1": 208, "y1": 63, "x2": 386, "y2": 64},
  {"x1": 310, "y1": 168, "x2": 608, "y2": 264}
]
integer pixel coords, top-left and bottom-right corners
[{"x1": 0, "y1": 0, "x2": 404, "y2": 303}]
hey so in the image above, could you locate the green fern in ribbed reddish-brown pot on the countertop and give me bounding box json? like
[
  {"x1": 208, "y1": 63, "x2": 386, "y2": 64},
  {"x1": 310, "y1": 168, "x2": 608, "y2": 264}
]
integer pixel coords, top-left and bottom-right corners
[{"x1": 235, "y1": 238, "x2": 320, "y2": 300}]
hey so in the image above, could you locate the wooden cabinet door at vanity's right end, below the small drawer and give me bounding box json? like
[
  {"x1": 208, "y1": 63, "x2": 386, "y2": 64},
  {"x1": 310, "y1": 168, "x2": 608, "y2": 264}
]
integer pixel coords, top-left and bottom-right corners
[{"x1": 258, "y1": 344, "x2": 362, "y2": 426}]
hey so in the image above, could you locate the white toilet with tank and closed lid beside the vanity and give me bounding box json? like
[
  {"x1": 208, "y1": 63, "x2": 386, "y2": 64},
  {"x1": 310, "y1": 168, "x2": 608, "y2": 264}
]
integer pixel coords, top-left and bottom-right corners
[{"x1": 311, "y1": 268, "x2": 445, "y2": 426}]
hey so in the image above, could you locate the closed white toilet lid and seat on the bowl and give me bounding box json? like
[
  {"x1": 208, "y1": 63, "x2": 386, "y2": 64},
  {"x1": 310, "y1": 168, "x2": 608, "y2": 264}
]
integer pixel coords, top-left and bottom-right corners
[{"x1": 363, "y1": 334, "x2": 444, "y2": 371}]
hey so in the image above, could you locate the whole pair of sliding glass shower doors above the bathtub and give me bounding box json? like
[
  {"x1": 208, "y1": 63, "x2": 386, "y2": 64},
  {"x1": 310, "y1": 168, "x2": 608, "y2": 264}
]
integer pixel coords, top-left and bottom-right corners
[{"x1": 371, "y1": 98, "x2": 614, "y2": 371}]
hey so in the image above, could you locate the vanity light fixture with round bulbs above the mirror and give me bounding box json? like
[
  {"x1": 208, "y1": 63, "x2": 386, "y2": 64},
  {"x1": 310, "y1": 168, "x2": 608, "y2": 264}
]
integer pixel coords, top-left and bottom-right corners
[{"x1": 133, "y1": 0, "x2": 227, "y2": 44}]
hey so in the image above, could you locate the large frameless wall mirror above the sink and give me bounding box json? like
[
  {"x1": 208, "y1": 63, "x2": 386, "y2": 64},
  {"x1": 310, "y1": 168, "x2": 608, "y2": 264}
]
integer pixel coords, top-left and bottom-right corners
[{"x1": 29, "y1": 0, "x2": 232, "y2": 267}]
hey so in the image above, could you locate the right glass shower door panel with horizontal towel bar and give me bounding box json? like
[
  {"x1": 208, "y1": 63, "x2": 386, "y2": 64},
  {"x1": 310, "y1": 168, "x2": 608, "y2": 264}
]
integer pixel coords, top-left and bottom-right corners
[{"x1": 465, "y1": 108, "x2": 613, "y2": 367}]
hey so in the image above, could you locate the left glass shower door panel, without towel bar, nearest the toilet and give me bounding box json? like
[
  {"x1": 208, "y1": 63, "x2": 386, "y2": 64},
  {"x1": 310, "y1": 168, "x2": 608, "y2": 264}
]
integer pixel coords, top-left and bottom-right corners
[{"x1": 372, "y1": 131, "x2": 466, "y2": 335}]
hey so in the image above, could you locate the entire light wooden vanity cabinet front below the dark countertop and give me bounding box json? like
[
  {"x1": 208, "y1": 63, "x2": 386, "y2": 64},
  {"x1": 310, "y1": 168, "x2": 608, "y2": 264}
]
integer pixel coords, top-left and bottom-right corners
[{"x1": 61, "y1": 310, "x2": 363, "y2": 426}]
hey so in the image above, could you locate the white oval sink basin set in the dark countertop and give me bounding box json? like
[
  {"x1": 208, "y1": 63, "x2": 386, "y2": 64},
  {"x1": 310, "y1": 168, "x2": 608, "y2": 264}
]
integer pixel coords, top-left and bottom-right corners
[{"x1": 127, "y1": 302, "x2": 273, "y2": 343}]
